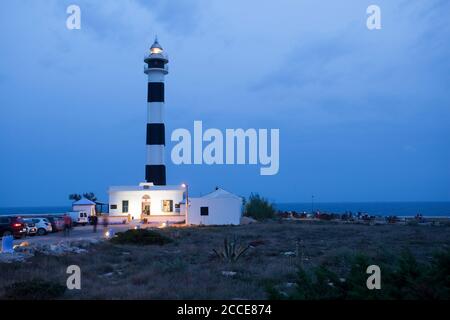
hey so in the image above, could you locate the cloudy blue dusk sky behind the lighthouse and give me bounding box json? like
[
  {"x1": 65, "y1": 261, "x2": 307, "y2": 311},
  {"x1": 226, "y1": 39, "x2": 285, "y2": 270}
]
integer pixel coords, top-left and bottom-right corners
[{"x1": 0, "y1": 0, "x2": 450, "y2": 206}]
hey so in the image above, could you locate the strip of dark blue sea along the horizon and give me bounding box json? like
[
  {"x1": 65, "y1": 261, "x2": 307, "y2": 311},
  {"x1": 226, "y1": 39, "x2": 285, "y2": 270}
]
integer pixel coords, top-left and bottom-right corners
[{"x1": 0, "y1": 202, "x2": 450, "y2": 217}]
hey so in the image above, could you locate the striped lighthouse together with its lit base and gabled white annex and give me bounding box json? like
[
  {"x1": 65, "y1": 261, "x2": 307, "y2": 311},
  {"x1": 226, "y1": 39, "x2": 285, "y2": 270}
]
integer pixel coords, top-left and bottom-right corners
[{"x1": 108, "y1": 39, "x2": 242, "y2": 227}]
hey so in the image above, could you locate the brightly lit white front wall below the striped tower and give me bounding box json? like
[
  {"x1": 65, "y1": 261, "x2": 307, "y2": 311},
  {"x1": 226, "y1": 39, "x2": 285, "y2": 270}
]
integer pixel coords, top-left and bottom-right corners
[{"x1": 109, "y1": 190, "x2": 183, "y2": 219}]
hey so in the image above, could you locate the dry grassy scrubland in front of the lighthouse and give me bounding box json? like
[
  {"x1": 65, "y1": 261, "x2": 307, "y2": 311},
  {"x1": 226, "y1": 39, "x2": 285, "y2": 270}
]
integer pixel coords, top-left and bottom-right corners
[{"x1": 0, "y1": 221, "x2": 450, "y2": 299}]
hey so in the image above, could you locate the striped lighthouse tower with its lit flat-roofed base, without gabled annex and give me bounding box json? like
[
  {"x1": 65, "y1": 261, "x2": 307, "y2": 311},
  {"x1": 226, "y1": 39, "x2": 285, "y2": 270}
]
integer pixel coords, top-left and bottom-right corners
[{"x1": 108, "y1": 39, "x2": 186, "y2": 224}]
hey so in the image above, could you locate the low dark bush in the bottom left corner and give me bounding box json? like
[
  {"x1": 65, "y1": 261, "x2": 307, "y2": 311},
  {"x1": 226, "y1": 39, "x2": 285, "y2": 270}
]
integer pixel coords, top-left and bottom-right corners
[{"x1": 5, "y1": 279, "x2": 66, "y2": 300}]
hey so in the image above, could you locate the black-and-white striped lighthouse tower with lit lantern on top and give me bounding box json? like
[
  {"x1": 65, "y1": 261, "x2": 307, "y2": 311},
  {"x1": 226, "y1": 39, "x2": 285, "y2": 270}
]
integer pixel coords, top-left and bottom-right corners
[{"x1": 144, "y1": 39, "x2": 169, "y2": 186}]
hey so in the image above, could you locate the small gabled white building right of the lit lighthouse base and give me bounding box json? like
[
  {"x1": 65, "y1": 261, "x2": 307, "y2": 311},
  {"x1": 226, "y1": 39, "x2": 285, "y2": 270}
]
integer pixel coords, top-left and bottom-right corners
[{"x1": 181, "y1": 188, "x2": 243, "y2": 225}]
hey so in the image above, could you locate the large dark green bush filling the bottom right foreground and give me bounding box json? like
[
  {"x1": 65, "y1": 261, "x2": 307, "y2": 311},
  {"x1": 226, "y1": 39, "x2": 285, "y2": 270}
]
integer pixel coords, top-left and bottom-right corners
[{"x1": 267, "y1": 249, "x2": 450, "y2": 300}]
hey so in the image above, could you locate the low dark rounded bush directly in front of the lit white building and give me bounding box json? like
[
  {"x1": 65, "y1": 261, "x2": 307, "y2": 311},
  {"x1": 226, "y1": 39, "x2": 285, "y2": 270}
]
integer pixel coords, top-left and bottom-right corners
[{"x1": 111, "y1": 229, "x2": 173, "y2": 246}]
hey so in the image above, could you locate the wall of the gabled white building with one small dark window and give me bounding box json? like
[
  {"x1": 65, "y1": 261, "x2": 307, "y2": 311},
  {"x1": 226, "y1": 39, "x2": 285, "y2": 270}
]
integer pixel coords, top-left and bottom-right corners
[{"x1": 185, "y1": 198, "x2": 242, "y2": 225}]
